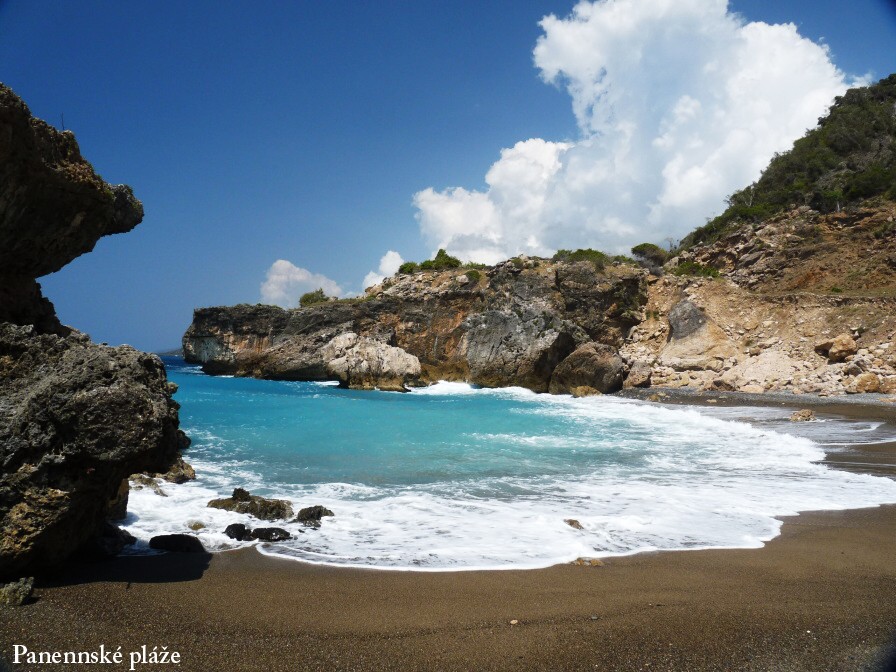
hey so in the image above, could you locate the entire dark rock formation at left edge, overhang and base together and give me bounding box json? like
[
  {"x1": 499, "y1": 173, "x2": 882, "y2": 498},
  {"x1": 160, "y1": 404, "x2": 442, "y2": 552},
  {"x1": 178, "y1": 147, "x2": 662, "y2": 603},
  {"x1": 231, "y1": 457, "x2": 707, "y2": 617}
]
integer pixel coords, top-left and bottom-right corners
[{"x1": 0, "y1": 84, "x2": 185, "y2": 577}]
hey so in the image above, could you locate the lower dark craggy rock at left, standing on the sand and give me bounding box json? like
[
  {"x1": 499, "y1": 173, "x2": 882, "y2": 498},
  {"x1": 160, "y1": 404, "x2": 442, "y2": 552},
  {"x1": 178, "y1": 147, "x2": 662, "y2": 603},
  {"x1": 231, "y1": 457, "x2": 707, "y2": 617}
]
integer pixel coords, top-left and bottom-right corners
[{"x1": 0, "y1": 323, "x2": 183, "y2": 576}]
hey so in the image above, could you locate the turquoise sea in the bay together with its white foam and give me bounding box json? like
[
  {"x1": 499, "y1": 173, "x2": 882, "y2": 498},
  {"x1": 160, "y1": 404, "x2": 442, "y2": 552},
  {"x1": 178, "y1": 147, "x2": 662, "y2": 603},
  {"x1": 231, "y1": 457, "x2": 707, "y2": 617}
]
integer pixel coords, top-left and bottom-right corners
[{"x1": 123, "y1": 357, "x2": 896, "y2": 571}]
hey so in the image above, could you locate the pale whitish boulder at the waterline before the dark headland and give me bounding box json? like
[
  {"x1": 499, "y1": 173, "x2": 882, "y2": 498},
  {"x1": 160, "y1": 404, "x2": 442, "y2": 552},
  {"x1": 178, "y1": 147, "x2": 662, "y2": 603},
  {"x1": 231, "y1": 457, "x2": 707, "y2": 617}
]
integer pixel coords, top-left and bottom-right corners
[{"x1": 321, "y1": 332, "x2": 420, "y2": 392}]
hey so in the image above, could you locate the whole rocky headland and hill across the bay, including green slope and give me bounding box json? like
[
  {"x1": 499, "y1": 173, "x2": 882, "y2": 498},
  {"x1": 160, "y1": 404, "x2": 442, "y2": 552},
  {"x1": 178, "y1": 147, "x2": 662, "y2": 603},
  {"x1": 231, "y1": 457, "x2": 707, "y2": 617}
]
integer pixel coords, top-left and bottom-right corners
[{"x1": 183, "y1": 75, "x2": 896, "y2": 394}]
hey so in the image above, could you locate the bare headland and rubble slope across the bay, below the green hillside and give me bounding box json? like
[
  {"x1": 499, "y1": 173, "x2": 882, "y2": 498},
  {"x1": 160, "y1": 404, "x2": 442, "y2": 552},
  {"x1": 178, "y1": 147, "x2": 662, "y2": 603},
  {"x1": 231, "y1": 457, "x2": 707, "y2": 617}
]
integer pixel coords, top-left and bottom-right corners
[{"x1": 183, "y1": 200, "x2": 896, "y2": 394}]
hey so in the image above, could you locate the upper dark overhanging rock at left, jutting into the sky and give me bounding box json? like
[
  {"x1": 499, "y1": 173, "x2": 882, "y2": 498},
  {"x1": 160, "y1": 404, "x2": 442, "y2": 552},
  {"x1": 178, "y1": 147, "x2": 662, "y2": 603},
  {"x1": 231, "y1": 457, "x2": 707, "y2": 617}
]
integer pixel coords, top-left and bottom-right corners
[{"x1": 0, "y1": 84, "x2": 143, "y2": 333}]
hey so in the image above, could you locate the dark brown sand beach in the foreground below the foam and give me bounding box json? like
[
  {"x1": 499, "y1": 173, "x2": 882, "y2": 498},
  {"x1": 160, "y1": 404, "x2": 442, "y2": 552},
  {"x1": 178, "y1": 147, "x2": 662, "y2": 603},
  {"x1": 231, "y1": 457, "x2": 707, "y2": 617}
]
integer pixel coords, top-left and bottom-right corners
[{"x1": 0, "y1": 402, "x2": 896, "y2": 672}]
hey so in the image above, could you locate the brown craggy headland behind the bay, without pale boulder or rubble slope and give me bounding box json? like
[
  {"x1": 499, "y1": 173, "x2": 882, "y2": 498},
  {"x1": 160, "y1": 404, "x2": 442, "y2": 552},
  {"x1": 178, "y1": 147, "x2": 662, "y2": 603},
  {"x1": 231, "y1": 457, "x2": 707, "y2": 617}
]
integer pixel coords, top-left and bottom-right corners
[{"x1": 183, "y1": 259, "x2": 647, "y2": 392}]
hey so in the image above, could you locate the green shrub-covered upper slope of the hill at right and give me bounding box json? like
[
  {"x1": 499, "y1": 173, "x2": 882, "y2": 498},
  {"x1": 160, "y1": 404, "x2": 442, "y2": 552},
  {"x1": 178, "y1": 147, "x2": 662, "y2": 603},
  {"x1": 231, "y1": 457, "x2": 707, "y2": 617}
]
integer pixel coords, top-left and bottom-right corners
[{"x1": 681, "y1": 74, "x2": 896, "y2": 249}]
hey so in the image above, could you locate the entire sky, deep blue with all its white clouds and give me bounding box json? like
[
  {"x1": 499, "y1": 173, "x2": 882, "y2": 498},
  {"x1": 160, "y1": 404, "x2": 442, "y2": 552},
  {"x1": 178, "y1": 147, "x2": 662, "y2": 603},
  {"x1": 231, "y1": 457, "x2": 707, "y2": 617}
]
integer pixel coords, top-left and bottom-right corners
[{"x1": 0, "y1": 0, "x2": 896, "y2": 351}]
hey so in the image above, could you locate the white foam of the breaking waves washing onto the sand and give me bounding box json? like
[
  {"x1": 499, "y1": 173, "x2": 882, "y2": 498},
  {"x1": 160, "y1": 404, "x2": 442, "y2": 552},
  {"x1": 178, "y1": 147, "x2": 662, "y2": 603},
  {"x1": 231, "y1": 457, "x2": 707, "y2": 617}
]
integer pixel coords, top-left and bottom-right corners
[{"x1": 126, "y1": 383, "x2": 896, "y2": 571}]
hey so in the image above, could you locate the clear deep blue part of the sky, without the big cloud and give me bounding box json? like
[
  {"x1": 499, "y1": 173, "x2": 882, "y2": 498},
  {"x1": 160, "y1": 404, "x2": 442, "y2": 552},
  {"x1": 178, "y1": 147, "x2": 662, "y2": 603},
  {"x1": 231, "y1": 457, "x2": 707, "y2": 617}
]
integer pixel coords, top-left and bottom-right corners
[{"x1": 0, "y1": 0, "x2": 896, "y2": 350}]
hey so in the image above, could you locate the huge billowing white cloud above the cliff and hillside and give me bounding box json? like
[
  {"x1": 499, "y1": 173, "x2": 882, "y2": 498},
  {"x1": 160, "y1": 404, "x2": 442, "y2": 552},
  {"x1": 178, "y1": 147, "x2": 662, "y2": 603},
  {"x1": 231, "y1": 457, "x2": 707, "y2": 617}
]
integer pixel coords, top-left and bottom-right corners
[{"x1": 414, "y1": 0, "x2": 847, "y2": 263}]
